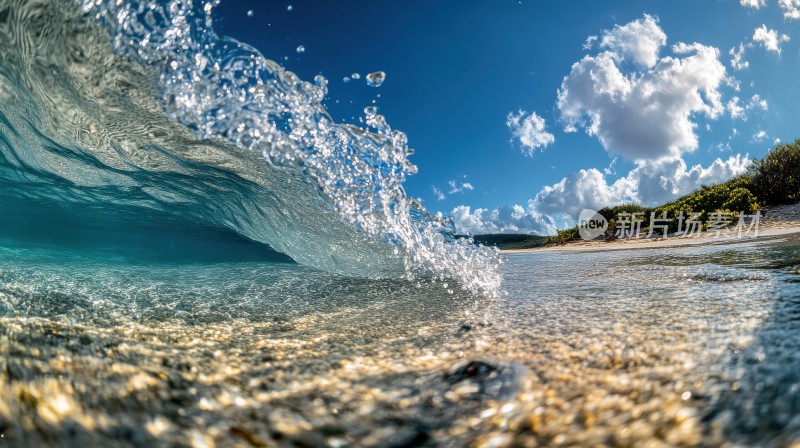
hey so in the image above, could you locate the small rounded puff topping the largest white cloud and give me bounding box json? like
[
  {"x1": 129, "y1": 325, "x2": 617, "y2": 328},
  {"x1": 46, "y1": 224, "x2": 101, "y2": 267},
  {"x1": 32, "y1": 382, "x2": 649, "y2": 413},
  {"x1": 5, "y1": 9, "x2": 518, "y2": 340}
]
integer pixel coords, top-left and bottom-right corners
[{"x1": 600, "y1": 14, "x2": 667, "y2": 67}]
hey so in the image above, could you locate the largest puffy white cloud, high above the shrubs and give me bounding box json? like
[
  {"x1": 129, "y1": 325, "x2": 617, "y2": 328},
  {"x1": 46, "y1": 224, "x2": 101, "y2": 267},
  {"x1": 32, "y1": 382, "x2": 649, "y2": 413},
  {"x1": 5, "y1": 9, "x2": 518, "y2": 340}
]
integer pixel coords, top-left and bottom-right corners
[{"x1": 558, "y1": 15, "x2": 726, "y2": 161}]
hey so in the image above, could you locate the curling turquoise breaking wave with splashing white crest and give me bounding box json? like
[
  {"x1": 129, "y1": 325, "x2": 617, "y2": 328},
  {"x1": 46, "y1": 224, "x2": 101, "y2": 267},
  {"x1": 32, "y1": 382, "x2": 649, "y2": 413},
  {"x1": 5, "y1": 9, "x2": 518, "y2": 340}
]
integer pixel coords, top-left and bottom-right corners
[{"x1": 0, "y1": 0, "x2": 501, "y2": 295}]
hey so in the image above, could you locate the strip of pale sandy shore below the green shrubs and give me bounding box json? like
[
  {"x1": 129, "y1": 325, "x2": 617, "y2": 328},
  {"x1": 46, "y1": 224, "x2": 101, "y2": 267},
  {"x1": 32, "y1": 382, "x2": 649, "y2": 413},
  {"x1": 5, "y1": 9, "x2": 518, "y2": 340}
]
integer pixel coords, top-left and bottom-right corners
[{"x1": 503, "y1": 204, "x2": 800, "y2": 254}]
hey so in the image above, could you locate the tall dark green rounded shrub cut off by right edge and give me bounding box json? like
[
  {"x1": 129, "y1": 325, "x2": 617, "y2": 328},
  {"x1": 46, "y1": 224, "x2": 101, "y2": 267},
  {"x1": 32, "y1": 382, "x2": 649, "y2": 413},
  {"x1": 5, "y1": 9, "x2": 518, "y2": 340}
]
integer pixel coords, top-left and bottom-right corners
[{"x1": 752, "y1": 140, "x2": 800, "y2": 205}]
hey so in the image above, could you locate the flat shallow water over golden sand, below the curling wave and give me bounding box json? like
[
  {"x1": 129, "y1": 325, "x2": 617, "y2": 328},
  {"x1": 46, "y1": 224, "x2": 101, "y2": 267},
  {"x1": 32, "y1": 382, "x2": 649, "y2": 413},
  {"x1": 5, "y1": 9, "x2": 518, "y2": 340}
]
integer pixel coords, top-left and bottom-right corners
[{"x1": 0, "y1": 233, "x2": 800, "y2": 446}]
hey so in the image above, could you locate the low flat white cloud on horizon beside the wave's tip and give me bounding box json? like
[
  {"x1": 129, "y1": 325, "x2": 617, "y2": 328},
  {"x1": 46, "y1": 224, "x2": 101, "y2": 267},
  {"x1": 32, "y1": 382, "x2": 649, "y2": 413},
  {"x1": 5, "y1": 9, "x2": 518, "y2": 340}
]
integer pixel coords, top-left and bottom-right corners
[{"x1": 452, "y1": 205, "x2": 556, "y2": 235}]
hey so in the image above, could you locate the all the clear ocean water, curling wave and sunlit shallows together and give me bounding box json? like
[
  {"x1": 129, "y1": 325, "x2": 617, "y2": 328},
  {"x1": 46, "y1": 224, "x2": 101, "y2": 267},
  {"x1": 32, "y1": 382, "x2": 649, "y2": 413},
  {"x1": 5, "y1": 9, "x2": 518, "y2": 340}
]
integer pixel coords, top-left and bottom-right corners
[{"x1": 0, "y1": 0, "x2": 800, "y2": 447}]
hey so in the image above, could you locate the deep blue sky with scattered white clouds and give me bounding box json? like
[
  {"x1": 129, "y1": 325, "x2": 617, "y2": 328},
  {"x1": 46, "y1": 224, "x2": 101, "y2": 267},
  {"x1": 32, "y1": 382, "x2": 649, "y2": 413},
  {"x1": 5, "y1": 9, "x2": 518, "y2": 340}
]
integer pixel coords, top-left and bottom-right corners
[{"x1": 215, "y1": 0, "x2": 800, "y2": 234}]
